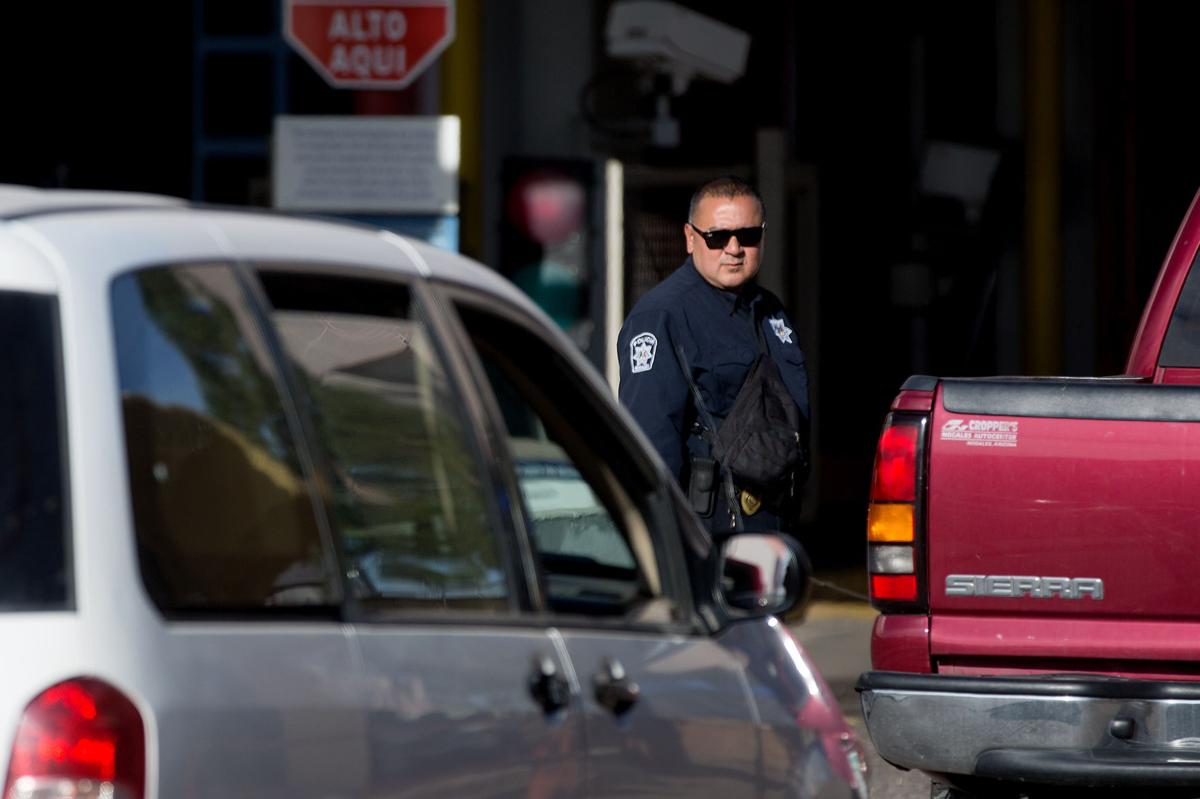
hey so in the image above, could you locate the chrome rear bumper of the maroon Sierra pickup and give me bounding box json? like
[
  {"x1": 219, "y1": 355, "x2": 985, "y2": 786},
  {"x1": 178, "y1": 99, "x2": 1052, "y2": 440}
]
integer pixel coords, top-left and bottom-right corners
[{"x1": 857, "y1": 672, "x2": 1200, "y2": 788}]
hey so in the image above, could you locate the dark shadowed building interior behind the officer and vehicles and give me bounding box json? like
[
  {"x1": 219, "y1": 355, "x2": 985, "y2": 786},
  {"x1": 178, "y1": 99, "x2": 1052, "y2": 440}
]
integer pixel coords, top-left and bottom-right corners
[{"x1": 0, "y1": 0, "x2": 1200, "y2": 566}]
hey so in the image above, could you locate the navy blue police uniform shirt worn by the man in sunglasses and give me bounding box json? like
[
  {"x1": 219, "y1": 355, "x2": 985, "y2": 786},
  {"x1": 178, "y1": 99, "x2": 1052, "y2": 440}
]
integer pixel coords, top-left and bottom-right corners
[{"x1": 617, "y1": 258, "x2": 809, "y2": 529}]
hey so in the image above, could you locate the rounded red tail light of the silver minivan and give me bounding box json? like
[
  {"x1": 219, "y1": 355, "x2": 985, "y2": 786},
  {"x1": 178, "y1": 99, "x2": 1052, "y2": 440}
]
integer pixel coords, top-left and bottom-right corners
[{"x1": 4, "y1": 677, "x2": 145, "y2": 799}]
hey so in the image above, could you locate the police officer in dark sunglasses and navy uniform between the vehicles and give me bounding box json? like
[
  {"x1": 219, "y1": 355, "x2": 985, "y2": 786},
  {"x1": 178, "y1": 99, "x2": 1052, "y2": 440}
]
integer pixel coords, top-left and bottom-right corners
[{"x1": 617, "y1": 178, "x2": 809, "y2": 534}]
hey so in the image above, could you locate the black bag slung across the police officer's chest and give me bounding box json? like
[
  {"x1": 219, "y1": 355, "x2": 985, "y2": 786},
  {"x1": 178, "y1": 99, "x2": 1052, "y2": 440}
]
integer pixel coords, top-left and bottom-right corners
[{"x1": 712, "y1": 352, "x2": 808, "y2": 488}]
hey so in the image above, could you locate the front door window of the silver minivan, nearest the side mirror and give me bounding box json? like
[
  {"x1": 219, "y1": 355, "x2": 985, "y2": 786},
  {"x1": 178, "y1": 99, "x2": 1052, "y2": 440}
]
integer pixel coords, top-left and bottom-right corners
[{"x1": 456, "y1": 295, "x2": 679, "y2": 621}]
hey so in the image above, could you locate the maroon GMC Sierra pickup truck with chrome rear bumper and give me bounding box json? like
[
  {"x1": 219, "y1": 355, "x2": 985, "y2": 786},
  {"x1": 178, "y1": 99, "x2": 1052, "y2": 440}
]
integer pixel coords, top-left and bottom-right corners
[{"x1": 858, "y1": 189, "x2": 1200, "y2": 797}]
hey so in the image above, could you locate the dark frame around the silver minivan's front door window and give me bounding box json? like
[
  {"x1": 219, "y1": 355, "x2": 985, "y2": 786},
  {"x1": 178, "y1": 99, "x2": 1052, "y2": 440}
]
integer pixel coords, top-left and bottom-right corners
[{"x1": 430, "y1": 280, "x2": 710, "y2": 635}]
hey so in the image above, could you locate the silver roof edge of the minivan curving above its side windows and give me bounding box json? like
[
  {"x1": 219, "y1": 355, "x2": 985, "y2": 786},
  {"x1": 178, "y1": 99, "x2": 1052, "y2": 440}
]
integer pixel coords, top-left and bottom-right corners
[{"x1": 0, "y1": 185, "x2": 548, "y2": 322}]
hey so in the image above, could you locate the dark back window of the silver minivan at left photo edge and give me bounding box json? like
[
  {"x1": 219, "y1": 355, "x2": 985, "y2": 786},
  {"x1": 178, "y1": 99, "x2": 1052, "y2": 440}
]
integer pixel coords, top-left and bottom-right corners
[{"x1": 0, "y1": 292, "x2": 72, "y2": 611}]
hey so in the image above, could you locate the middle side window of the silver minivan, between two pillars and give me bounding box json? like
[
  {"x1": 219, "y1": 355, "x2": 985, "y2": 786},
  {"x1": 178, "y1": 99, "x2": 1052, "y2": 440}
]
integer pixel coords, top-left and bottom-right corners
[{"x1": 260, "y1": 270, "x2": 510, "y2": 611}]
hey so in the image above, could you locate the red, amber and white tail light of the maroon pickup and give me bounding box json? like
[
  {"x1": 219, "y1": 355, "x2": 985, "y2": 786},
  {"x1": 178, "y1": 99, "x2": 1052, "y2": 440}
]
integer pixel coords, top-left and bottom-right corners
[{"x1": 866, "y1": 413, "x2": 926, "y2": 611}]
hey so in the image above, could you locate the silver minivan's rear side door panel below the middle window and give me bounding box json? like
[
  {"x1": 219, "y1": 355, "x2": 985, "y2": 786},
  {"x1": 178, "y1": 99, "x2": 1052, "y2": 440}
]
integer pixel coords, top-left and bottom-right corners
[{"x1": 356, "y1": 621, "x2": 587, "y2": 799}]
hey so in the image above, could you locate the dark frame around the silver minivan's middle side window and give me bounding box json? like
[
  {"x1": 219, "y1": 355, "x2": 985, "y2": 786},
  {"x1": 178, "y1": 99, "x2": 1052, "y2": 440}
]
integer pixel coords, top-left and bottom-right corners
[{"x1": 244, "y1": 258, "x2": 533, "y2": 625}]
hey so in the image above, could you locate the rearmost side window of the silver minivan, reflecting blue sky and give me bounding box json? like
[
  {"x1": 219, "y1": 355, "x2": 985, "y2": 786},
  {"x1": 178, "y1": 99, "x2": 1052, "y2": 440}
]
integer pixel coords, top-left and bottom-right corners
[{"x1": 112, "y1": 264, "x2": 338, "y2": 612}]
